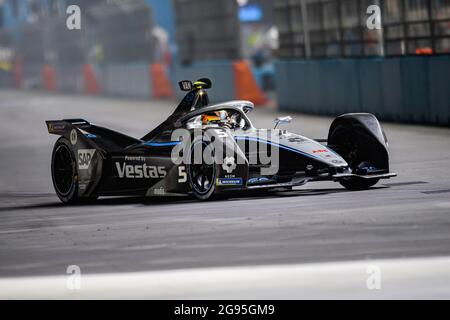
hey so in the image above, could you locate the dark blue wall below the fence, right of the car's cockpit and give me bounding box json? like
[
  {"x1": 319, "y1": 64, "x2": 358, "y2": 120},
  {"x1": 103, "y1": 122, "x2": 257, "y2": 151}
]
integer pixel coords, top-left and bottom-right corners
[{"x1": 276, "y1": 56, "x2": 450, "y2": 125}]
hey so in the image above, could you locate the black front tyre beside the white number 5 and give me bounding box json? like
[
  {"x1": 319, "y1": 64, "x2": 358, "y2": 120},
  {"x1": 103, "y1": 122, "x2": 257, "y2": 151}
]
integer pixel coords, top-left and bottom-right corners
[{"x1": 187, "y1": 139, "x2": 218, "y2": 201}]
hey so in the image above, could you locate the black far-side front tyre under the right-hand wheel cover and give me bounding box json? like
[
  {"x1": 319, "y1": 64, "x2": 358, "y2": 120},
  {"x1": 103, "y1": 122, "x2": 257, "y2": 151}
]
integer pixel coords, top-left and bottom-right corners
[{"x1": 331, "y1": 125, "x2": 380, "y2": 191}]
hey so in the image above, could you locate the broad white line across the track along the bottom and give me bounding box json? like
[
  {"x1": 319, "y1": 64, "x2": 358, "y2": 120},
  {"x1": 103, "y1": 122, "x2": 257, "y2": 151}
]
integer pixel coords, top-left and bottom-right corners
[{"x1": 0, "y1": 257, "x2": 450, "y2": 299}]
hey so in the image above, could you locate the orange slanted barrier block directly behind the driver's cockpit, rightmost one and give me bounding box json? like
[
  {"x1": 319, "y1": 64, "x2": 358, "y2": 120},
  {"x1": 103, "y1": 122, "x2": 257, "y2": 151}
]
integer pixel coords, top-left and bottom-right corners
[{"x1": 233, "y1": 60, "x2": 267, "y2": 105}]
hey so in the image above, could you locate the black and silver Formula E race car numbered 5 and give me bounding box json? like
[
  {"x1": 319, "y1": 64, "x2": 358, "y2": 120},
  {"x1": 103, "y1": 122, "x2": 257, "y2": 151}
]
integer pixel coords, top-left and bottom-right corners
[{"x1": 46, "y1": 78, "x2": 396, "y2": 204}]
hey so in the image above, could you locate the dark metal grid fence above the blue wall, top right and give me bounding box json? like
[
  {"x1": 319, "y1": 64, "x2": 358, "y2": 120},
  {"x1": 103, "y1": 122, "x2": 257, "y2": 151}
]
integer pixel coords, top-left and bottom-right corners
[{"x1": 274, "y1": 0, "x2": 450, "y2": 58}]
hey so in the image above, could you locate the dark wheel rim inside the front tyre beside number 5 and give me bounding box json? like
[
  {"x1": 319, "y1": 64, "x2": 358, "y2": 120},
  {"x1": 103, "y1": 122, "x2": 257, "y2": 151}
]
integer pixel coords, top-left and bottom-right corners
[{"x1": 189, "y1": 143, "x2": 216, "y2": 195}]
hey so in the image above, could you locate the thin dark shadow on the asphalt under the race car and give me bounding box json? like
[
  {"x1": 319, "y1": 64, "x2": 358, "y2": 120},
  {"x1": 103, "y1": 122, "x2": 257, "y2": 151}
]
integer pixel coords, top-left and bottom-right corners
[{"x1": 0, "y1": 186, "x2": 388, "y2": 212}]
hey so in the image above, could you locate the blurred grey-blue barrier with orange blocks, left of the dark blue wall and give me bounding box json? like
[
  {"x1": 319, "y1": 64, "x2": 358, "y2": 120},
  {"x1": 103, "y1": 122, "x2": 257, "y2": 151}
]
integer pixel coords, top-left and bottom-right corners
[{"x1": 3, "y1": 60, "x2": 267, "y2": 105}]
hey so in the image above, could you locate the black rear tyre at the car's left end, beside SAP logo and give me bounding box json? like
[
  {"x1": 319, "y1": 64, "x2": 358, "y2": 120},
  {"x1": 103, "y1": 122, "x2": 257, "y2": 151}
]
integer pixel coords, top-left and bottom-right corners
[{"x1": 51, "y1": 137, "x2": 97, "y2": 205}]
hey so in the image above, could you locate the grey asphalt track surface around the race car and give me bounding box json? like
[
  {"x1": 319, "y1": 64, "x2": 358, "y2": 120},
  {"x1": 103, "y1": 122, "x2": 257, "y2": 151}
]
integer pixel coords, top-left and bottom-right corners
[{"x1": 0, "y1": 90, "x2": 450, "y2": 297}]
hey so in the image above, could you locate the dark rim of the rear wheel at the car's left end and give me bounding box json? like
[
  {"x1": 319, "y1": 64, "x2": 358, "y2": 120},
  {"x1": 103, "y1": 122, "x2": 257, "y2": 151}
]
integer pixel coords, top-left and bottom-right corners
[{"x1": 53, "y1": 145, "x2": 75, "y2": 196}]
